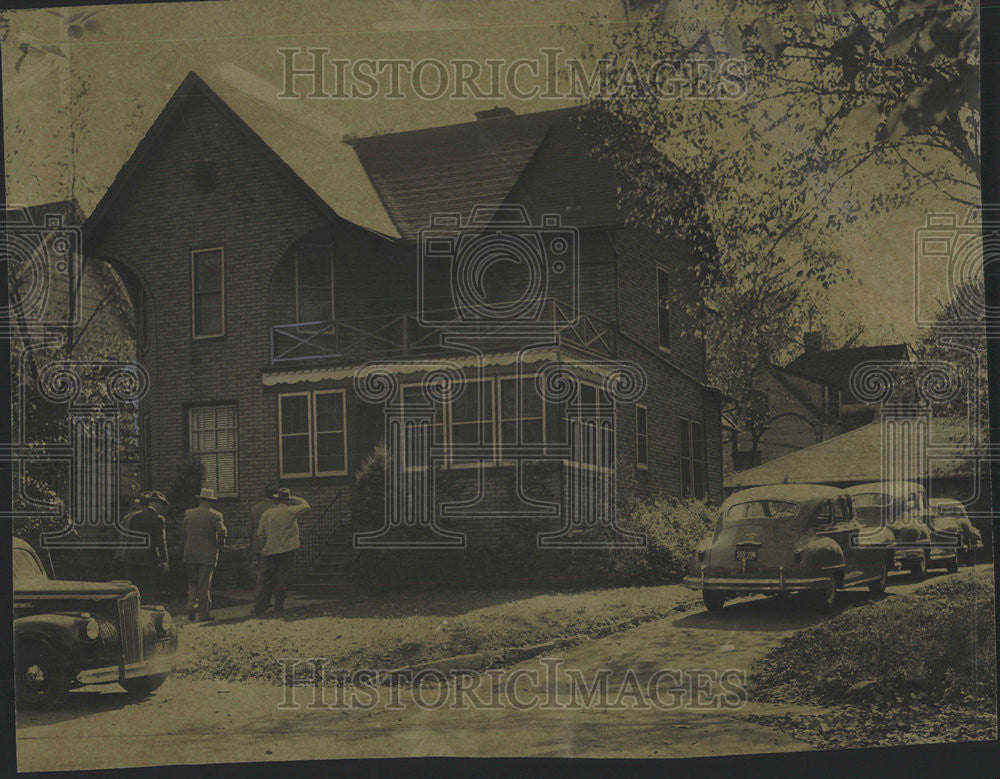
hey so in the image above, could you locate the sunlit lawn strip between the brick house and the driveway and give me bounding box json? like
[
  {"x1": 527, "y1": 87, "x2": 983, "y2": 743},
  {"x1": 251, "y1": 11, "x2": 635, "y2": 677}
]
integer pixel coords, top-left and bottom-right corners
[{"x1": 174, "y1": 585, "x2": 697, "y2": 683}]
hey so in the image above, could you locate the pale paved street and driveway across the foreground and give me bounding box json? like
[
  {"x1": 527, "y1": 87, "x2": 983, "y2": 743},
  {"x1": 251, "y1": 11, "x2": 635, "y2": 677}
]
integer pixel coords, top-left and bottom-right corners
[{"x1": 17, "y1": 566, "x2": 993, "y2": 770}]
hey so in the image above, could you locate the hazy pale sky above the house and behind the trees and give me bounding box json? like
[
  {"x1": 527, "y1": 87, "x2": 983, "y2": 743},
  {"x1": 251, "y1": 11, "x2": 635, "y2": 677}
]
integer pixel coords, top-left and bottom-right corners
[{"x1": 2, "y1": 0, "x2": 984, "y2": 344}]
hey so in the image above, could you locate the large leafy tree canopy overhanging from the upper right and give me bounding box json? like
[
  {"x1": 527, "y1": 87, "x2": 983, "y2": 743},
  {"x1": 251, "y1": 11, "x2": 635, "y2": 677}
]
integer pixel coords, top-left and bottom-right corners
[{"x1": 586, "y1": 0, "x2": 979, "y2": 464}]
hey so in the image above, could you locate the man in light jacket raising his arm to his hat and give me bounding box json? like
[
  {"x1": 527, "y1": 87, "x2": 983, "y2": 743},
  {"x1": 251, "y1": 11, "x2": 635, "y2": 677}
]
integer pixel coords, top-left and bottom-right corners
[{"x1": 253, "y1": 487, "x2": 310, "y2": 614}]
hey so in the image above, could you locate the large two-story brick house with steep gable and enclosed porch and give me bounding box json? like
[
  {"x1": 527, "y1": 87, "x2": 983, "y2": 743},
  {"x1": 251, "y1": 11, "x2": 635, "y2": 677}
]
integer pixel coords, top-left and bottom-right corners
[{"x1": 76, "y1": 73, "x2": 722, "y2": 575}]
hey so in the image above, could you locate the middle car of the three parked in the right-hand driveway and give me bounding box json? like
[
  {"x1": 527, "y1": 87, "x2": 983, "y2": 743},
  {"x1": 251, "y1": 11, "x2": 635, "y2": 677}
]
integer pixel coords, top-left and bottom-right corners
[{"x1": 847, "y1": 481, "x2": 958, "y2": 579}]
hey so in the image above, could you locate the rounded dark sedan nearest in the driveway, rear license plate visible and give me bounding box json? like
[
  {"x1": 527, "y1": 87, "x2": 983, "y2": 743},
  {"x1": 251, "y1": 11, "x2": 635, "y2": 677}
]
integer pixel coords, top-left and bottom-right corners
[{"x1": 684, "y1": 484, "x2": 893, "y2": 611}]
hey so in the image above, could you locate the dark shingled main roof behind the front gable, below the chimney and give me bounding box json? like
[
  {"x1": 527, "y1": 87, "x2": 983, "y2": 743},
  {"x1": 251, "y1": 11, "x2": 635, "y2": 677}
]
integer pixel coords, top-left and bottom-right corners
[{"x1": 350, "y1": 108, "x2": 620, "y2": 240}]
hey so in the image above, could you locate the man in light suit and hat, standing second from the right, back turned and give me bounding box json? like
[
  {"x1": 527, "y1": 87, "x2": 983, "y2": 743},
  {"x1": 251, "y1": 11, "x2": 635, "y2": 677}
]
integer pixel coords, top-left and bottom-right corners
[{"x1": 181, "y1": 487, "x2": 226, "y2": 622}]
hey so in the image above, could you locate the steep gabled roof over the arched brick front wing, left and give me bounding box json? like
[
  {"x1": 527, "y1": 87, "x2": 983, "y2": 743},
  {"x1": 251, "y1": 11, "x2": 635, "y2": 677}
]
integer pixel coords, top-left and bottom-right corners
[{"x1": 85, "y1": 72, "x2": 399, "y2": 244}]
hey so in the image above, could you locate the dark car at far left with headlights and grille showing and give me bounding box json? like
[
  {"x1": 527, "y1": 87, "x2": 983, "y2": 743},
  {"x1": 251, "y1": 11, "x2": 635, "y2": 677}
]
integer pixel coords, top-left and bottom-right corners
[{"x1": 12, "y1": 538, "x2": 177, "y2": 707}]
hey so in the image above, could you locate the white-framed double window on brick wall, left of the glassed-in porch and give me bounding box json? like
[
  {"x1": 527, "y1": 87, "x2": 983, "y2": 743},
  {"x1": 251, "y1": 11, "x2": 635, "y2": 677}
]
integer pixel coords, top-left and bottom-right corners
[{"x1": 278, "y1": 390, "x2": 347, "y2": 478}]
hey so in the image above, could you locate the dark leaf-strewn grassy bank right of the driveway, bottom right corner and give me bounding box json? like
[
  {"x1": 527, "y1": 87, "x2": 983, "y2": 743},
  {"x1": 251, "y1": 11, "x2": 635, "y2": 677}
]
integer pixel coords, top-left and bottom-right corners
[{"x1": 750, "y1": 573, "x2": 997, "y2": 706}]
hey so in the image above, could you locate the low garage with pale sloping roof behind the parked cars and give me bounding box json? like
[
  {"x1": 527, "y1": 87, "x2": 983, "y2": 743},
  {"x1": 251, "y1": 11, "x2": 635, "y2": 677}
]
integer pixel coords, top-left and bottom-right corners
[{"x1": 726, "y1": 414, "x2": 993, "y2": 548}]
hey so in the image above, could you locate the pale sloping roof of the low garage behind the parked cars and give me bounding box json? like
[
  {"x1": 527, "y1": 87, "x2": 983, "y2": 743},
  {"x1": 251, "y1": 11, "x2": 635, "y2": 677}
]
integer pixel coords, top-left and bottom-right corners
[{"x1": 726, "y1": 417, "x2": 971, "y2": 488}]
